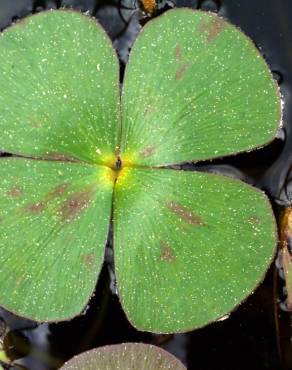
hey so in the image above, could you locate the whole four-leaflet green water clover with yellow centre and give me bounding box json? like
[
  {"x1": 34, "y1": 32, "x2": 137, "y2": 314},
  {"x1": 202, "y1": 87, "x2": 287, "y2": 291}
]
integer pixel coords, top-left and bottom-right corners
[{"x1": 0, "y1": 9, "x2": 281, "y2": 333}]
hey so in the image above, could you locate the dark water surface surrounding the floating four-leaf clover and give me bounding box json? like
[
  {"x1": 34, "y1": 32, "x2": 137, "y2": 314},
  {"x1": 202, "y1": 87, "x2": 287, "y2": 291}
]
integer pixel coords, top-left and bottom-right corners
[{"x1": 0, "y1": 0, "x2": 292, "y2": 370}]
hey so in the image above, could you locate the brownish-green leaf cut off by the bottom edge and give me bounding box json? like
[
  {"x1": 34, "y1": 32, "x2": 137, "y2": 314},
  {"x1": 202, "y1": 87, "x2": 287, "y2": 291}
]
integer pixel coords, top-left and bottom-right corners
[{"x1": 61, "y1": 343, "x2": 186, "y2": 370}]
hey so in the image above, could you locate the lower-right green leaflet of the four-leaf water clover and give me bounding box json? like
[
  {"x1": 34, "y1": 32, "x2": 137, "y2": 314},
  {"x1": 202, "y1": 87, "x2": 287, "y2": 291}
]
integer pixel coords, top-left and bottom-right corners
[{"x1": 114, "y1": 169, "x2": 276, "y2": 333}]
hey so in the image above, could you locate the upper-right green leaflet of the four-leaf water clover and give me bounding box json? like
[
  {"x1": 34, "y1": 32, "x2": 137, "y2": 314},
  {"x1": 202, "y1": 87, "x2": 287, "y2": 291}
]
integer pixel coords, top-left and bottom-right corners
[{"x1": 122, "y1": 9, "x2": 281, "y2": 166}]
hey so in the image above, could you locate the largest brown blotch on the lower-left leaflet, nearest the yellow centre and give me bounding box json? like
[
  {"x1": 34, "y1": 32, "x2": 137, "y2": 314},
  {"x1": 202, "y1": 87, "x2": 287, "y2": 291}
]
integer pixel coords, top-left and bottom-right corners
[{"x1": 61, "y1": 191, "x2": 92, "y2": 222}]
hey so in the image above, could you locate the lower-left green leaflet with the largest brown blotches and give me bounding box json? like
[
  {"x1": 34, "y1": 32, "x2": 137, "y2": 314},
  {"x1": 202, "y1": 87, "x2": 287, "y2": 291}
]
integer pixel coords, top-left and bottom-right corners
[{"x1": 0, "y1": 158, "x2": 112, "y2": 321}]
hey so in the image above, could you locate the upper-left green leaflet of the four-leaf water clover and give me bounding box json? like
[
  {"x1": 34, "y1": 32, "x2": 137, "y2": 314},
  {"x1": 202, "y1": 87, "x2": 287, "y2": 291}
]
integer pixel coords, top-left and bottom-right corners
[{"x1": 0, "y1": 10, "x2": 119, "y2": 163}]
